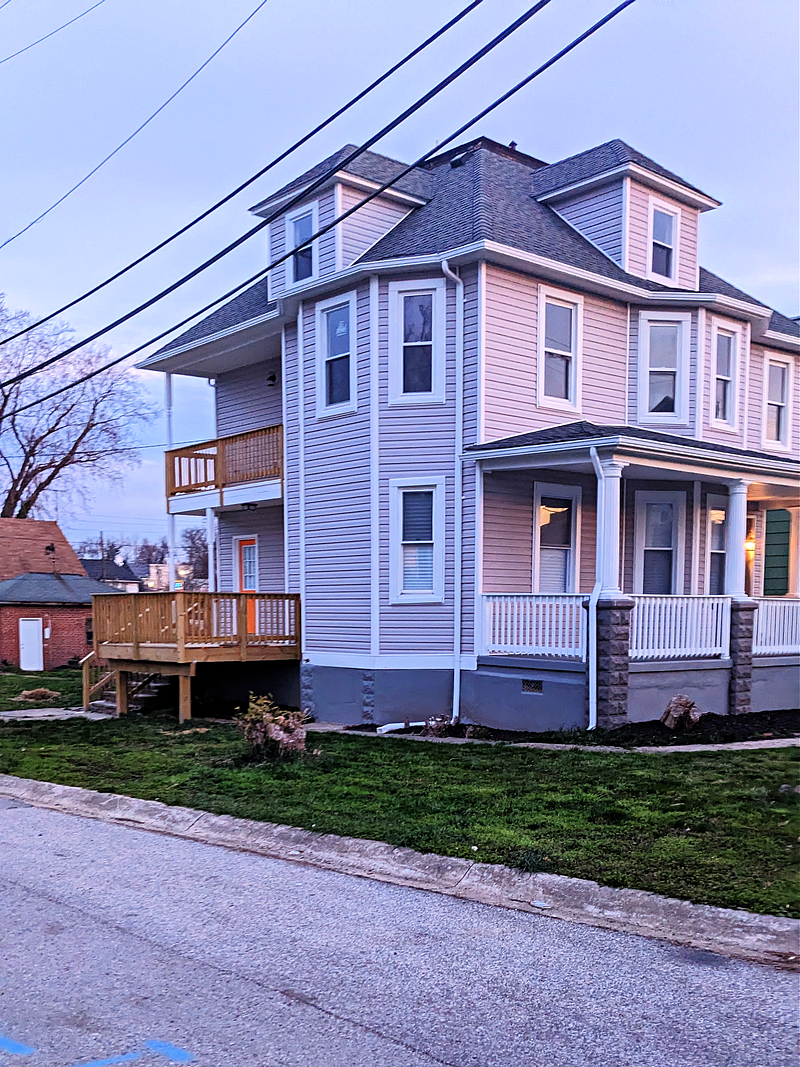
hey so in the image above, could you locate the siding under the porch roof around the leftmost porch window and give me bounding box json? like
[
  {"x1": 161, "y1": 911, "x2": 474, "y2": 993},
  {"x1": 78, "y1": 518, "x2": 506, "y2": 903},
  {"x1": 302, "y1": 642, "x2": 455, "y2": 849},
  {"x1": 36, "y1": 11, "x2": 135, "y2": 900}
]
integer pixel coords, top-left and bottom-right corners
[{"x1": 483, "y1": 471, "x2": 596, "y2": 593}]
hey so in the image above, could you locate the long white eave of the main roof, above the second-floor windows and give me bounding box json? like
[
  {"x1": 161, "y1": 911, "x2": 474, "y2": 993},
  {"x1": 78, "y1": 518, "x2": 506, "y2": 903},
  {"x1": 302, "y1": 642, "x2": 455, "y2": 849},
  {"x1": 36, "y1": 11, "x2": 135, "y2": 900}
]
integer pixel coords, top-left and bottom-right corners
[{"x1": 137, "y1": 240, "x2": 776, "y2": 377}]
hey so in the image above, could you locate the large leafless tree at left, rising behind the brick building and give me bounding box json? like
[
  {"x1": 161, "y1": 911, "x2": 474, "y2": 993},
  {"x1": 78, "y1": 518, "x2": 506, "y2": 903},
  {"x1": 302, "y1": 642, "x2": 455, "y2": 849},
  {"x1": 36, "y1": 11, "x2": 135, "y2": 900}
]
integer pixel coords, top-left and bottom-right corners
[{"x1": 0, "y1": 297, "x2": 155, "y2": 519}]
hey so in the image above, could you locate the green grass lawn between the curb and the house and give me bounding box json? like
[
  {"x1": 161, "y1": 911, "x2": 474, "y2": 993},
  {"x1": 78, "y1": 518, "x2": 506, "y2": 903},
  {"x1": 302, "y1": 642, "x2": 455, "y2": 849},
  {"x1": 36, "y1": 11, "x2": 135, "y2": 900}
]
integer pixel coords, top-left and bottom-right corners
[{"x1": 0, "y1": 715, "x2": 800, "y2": 917}]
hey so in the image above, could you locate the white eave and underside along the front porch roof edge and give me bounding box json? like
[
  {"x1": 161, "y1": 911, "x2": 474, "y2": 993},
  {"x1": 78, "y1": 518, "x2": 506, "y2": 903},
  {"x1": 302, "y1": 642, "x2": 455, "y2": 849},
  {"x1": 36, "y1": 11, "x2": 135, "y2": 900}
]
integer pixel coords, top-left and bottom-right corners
[{"x1": 463, "y1": 434, "x2": 800, "y2": 488}]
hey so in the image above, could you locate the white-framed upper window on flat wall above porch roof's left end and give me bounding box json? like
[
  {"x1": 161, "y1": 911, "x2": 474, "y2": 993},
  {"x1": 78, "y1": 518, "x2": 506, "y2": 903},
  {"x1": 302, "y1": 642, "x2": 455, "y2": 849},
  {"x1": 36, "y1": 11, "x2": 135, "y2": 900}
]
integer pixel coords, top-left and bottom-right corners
[{"x1": 538, "y1": 286, "x2": 582, "y2": 411}]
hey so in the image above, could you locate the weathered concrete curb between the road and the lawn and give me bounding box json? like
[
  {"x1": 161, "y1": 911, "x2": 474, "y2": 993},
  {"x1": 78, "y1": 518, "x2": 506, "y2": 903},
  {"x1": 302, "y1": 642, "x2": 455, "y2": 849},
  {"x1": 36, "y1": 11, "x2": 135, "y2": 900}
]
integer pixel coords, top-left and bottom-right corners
[{"x1": 0, "y1": 775, "x2": 800, "y2": 969}]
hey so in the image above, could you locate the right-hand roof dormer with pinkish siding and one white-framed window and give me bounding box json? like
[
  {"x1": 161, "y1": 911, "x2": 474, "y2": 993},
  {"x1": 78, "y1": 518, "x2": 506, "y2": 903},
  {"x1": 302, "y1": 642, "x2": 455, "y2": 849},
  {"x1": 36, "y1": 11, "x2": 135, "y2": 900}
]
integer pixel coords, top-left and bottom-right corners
[{"x1": 532, "y1": 141, "x2": 720, "y2": 289}]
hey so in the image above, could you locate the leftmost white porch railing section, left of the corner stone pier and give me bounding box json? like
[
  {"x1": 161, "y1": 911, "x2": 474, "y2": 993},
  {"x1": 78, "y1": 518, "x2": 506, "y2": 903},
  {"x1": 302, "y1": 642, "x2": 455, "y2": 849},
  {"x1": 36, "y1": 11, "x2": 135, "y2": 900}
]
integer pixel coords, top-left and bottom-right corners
[{"x1": 483, "y1": 593, "x2": 587, "y2": 659}]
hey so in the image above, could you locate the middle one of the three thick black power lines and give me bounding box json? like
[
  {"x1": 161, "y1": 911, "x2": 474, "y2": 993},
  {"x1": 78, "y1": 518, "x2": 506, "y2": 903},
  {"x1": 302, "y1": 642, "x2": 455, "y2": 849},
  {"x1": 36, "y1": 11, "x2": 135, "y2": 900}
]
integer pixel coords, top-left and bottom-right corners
[{"x1": 0, "y1": 0, "x2": 551, "y2": 387}]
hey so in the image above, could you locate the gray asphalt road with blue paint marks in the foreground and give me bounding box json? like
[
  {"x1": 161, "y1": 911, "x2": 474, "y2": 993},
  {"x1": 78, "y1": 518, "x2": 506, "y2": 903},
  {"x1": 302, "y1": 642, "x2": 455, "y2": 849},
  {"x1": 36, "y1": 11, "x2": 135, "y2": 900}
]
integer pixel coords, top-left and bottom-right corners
[{"x1": 0, "y1": 798, "x2": 798, "y2": 1067}]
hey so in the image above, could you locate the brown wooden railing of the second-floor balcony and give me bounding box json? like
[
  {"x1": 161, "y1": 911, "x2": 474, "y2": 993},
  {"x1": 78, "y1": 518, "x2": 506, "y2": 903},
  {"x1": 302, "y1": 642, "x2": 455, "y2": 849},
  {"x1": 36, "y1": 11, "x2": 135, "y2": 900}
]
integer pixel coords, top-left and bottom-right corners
[{"x1": 164, "y1": 426, "x2": 284, "y2": 497}]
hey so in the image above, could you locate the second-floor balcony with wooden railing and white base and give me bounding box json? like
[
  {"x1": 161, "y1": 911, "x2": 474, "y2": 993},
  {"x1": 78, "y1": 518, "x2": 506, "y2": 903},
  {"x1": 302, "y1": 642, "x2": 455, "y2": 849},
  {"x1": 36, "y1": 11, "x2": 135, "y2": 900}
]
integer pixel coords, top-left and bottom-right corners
[{"x1": 164, "y1": 426, "x2": 284, "y2": 514}]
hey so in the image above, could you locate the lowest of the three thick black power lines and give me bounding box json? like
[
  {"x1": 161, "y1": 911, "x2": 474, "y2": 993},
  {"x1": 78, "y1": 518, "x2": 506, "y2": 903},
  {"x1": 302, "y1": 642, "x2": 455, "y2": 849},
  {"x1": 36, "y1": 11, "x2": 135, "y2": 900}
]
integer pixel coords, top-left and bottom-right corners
[{"x1": 9, "y1": 0, "x2": 636, "y2": 417}]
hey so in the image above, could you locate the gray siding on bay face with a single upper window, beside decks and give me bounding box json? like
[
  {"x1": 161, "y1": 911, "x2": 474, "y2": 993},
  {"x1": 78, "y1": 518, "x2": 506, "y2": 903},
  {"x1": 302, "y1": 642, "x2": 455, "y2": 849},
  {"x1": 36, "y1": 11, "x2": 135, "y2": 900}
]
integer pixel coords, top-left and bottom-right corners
[{"x1": 304, "y1": 284, "x2": 370, "y2": 654}]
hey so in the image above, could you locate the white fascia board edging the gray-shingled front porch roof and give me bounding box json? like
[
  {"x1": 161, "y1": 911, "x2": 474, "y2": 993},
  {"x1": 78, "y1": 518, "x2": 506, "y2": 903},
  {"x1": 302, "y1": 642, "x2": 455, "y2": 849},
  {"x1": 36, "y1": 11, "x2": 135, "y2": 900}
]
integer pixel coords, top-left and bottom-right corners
[{"x1": 463, "y1": 434, "x2": 800, "y2": 481}]
